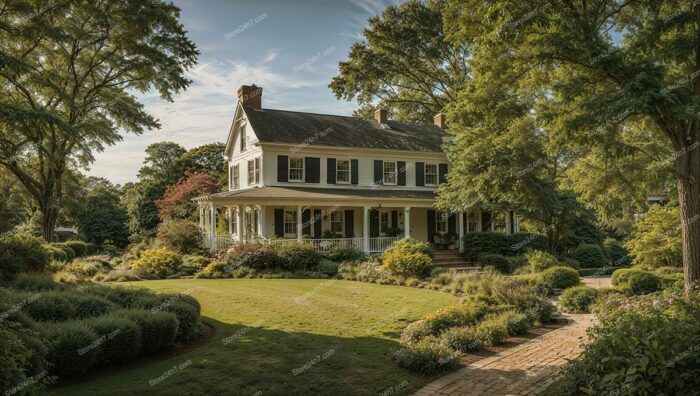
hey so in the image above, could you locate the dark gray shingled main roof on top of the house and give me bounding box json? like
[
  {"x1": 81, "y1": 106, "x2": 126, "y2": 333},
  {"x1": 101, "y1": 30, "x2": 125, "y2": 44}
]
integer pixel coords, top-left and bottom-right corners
[{"x1": 244, "y1": 107, "x2": 445, "y2": 152}]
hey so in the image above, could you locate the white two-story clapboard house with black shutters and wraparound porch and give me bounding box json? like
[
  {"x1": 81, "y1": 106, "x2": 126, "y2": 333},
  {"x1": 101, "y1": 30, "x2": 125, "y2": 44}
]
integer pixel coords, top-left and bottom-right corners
[{"x1": 195, "y1": 85, "x2": 518, "y2": 252}]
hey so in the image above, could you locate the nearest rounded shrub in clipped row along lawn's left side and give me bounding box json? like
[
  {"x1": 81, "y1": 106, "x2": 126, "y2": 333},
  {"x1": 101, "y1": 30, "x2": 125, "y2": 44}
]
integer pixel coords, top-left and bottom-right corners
[{"x1": 44, "y1": 322, "x2": 99, "y2": 377}]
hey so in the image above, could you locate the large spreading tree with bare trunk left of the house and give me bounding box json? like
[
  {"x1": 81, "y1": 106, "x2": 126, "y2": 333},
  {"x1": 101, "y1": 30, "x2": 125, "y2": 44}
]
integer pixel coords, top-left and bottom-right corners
[{"x1": 0, "y1": 0, "x2": 198, "y2": 240}]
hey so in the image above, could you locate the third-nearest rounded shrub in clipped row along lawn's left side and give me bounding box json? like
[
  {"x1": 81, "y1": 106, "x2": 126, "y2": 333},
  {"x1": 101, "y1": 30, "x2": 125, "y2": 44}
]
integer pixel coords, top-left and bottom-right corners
[{"x1": 114, "y1": 309, "x2": 178, "y2": 355}]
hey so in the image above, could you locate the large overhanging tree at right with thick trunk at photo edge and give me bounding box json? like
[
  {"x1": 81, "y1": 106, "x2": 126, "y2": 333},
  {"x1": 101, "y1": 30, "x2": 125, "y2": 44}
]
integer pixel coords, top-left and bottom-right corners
[{"x1": 446, "y1": 0, "x2": 700, "y2": 287}]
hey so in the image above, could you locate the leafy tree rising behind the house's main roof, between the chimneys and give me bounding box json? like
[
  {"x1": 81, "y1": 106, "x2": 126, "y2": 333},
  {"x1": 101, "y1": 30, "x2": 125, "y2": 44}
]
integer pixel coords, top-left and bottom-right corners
[{"x1": 330, "y1": 0, "x2": 469, "y2": 122}]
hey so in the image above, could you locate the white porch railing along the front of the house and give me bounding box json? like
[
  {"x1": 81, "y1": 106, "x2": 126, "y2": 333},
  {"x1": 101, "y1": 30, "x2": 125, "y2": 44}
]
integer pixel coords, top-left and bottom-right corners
[{"x1": 204, "y1": 234, "x2": 401, "y2": 253}]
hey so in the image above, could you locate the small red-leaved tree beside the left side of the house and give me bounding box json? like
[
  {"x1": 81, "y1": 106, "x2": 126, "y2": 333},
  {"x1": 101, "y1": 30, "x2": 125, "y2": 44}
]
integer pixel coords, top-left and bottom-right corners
[{"x1": 156, "y1": 173, "x2": 221, "y2": 221}]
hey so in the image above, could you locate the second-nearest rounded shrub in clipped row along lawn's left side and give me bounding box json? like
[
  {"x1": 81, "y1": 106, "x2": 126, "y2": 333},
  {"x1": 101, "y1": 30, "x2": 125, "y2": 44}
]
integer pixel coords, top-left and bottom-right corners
[{"x1": 86, "y1": 315, "x2": 141, "y2": 366}]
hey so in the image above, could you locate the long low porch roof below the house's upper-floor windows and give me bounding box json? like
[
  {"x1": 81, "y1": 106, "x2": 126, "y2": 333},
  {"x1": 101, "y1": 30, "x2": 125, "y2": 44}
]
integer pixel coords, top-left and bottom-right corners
[{"x1": 194, "y1": 186, "x2": 435, "y2": 202}]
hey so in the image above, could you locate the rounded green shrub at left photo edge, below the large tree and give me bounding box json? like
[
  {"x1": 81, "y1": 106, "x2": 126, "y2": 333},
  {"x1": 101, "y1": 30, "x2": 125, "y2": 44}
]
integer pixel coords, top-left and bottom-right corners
[{"x1": 0, "y1": 234, "x2": 51, "y2": 280}]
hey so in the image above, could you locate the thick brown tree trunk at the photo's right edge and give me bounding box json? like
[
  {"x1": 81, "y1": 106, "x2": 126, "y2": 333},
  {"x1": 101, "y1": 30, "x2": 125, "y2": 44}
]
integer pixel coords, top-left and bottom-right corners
[{"x1": 676, "y1": 141, "x2": 700, "y2": 290}]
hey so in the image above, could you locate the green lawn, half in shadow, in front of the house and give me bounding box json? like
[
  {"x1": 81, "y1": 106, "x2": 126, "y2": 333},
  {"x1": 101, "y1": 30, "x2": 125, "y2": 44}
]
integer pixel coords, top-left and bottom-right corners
[{"x1": 54, "y1": 279, "x2": 457, "y2": 395}]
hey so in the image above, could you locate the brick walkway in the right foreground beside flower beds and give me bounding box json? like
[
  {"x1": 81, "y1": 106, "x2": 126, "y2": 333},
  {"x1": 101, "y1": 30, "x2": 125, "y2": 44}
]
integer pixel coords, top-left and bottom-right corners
[{"x1": 415, "y1": 314, "x2": 592, "y2": 396}]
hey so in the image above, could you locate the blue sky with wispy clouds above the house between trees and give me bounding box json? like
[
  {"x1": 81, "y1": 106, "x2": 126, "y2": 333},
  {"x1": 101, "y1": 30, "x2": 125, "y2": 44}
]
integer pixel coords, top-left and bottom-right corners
[{"x1": 85, "y1": 0, "x2": 400, "y2": 184}]
